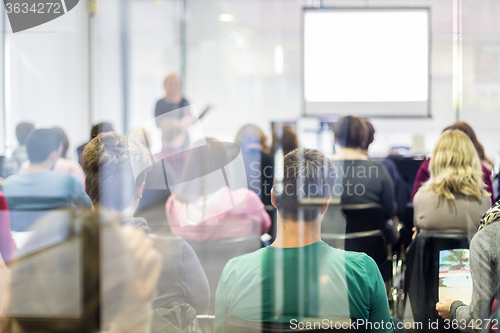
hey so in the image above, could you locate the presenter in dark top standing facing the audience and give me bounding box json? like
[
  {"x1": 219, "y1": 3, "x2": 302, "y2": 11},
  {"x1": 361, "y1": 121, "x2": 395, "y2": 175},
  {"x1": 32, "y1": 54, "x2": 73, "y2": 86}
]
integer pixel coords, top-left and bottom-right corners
[{"x1": 155, "y1": 73, "x2": 212, "y2": 128}]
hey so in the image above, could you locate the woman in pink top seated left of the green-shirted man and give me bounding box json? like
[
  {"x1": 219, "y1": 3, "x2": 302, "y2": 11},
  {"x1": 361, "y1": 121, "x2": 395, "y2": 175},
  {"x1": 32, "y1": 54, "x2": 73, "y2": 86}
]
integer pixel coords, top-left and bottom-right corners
[{"x1": 166, "y1": 138, "x2": 271, "y2": 242}]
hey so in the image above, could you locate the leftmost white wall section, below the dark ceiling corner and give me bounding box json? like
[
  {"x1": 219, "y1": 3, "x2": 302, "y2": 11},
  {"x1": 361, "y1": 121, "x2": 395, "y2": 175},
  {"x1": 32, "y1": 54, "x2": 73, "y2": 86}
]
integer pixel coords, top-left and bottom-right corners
[{"x1": 6, "y1": 1, "x2": 89, "y2": 157}]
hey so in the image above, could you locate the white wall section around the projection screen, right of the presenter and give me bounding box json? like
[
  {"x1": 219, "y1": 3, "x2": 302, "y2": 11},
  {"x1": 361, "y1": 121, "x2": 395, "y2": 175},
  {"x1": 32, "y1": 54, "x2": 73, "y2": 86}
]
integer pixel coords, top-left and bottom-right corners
[{"x1": 186, "y1": 0, "x2": 500, "y2": 167}]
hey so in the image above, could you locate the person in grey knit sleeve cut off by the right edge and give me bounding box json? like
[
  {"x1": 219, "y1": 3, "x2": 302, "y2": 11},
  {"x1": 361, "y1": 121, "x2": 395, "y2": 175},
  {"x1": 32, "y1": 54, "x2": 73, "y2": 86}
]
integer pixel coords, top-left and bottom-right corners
[{"x1": 436, "y1": 198, "x2": 500, "y2": 332}]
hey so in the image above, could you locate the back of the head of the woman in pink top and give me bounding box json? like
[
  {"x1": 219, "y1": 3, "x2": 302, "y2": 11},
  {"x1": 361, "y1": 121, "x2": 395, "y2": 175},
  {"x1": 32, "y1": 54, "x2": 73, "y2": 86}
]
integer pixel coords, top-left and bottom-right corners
[{"x1": 174, "y1": 138, "x2": 232, "y2": 202}]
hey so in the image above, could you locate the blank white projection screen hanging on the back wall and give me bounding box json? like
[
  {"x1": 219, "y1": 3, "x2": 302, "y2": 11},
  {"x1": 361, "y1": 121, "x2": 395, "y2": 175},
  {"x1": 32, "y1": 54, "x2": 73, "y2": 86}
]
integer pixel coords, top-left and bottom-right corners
[{"x1": 303, "y1": 7, "x2": 430, "y2": 117}]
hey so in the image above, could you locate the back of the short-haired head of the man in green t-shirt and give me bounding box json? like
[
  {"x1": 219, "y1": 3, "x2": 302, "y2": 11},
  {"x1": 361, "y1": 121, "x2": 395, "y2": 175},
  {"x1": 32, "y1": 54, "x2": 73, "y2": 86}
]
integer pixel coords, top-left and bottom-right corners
[{"x1": 273, "y1": 148, "x2": 337, "y2": 222}]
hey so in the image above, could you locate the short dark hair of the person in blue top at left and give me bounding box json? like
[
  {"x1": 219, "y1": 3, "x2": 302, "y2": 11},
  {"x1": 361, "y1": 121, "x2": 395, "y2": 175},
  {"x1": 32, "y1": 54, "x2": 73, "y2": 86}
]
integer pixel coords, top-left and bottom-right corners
[{"x1": 26, "y1": 128, "x2": 62, "y2": 164}]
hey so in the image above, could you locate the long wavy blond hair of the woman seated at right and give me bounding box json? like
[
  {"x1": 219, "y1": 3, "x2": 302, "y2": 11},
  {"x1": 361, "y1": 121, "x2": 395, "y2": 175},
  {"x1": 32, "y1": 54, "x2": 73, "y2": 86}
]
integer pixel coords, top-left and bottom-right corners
[{"x1": 424, "y1": 130, "x2": 490, "y2": 201}]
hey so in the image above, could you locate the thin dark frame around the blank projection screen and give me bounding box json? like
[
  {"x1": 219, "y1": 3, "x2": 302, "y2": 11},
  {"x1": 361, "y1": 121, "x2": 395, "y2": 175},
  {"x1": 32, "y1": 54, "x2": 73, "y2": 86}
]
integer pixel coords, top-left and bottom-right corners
[{"x1": 300, "y1": 6, "x2": 432, "y2": 119}]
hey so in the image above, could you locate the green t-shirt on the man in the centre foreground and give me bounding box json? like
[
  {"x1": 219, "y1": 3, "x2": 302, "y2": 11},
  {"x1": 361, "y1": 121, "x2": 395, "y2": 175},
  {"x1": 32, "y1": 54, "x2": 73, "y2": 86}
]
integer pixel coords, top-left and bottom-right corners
[{"x1": 215, "y1": 242, "x2": 393, "y2": 333}]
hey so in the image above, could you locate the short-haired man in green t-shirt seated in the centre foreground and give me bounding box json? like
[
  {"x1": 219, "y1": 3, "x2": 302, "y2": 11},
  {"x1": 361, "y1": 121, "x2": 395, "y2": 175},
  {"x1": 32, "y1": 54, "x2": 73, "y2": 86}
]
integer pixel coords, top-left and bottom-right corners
[{"x1": 215, "y1": 149, "x2": 393, "y2": 333}]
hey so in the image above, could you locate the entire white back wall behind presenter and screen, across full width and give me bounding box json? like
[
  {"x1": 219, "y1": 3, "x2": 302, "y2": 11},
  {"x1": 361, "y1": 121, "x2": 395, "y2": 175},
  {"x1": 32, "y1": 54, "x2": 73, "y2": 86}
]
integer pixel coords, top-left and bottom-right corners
[{"x1": 4, "y1": 0, "x2": 500, "y2": 167}]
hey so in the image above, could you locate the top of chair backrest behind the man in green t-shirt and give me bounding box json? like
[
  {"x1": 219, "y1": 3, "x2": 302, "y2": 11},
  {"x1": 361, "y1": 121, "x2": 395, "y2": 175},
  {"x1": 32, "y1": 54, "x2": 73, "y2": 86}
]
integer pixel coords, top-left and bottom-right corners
[{"x1": 224, "y1": 316, "x2": 365, "y2": 333}]
